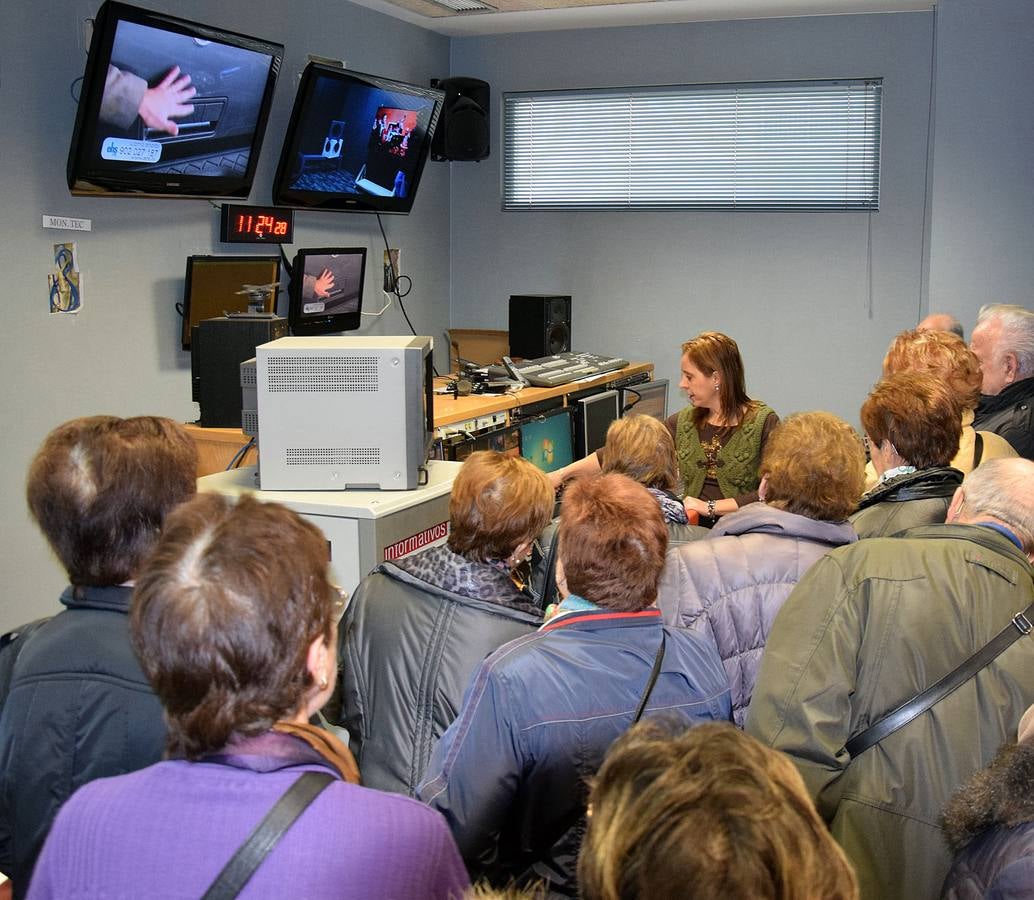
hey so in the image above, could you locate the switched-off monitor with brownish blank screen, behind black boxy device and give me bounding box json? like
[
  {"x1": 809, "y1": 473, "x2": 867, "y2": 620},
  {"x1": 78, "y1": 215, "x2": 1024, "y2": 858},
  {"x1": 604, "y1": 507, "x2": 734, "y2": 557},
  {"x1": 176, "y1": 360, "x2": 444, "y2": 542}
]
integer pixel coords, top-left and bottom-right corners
[{"x1": 180, "y1": 256, "x2": 280, "y2": 350}]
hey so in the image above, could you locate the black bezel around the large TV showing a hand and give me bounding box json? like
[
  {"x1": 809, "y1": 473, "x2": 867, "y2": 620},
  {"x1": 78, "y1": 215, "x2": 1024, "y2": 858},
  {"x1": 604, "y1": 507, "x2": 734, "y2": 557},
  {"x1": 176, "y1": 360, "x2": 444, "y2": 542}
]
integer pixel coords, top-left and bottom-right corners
[{"x1": 66, "y1": 0, "x2": 283, "y2": 200}]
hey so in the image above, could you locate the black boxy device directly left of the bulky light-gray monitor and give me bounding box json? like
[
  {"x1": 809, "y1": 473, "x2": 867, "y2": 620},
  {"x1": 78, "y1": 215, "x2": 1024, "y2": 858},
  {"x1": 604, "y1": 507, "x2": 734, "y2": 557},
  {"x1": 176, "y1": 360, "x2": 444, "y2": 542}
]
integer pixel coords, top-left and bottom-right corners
[{"x1": 190, "y1": 316, "x2": 287, "y2": 428}]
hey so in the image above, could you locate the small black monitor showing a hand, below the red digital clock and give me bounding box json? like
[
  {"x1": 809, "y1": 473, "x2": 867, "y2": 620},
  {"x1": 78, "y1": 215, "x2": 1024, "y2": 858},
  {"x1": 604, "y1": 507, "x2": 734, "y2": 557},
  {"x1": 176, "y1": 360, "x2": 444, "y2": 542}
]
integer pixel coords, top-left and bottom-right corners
[{"x1": 287, "y1": 247, "x2": 366, "y2": 335}]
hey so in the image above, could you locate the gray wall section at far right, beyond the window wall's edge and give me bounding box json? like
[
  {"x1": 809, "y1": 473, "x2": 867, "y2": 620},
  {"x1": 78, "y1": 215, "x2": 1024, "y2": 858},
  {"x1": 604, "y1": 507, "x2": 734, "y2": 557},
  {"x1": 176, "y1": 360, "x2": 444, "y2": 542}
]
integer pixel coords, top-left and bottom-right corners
[{"x1": 930, "y1": 0, "x2": 1034, "y2": 327}]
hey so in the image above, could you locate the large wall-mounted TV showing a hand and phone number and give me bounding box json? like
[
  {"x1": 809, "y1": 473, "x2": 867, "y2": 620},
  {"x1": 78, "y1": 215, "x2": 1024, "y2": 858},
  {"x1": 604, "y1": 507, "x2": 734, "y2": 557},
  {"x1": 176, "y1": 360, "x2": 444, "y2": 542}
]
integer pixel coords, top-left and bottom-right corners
[{"x1": 67, "y1": 0, "x2": 283, "y2": 198}]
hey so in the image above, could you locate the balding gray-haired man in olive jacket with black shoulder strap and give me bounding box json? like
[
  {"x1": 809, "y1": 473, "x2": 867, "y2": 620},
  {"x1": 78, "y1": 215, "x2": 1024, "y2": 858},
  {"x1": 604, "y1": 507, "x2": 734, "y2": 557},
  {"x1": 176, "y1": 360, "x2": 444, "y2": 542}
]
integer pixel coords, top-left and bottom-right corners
[{"x1": 747, "y1": 457, "x2": 1034, "y2": 900}]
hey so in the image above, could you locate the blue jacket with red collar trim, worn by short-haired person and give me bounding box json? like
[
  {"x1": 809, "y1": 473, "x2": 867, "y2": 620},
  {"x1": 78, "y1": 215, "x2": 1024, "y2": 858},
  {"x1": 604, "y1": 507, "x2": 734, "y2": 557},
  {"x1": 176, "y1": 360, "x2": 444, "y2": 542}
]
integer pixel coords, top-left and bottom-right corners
[{"x1": 417, "y1": 608, "x2": 731, "y2": 893}]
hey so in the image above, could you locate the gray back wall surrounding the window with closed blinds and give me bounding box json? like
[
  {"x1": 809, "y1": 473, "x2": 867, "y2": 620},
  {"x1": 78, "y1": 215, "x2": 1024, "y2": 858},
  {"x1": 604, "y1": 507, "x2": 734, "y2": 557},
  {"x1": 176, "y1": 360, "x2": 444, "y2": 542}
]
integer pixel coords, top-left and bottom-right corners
[{"x1": 451, "y1": 12, "x2": 934, "y2": 422}]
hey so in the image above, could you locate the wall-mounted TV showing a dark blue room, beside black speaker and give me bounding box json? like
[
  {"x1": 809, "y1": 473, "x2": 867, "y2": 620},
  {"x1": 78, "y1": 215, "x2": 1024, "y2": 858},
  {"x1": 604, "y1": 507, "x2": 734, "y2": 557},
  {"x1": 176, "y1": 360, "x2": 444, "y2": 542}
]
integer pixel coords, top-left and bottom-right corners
[{"x1": 273, "y1": 63, "x2": 445, "y2": 213}]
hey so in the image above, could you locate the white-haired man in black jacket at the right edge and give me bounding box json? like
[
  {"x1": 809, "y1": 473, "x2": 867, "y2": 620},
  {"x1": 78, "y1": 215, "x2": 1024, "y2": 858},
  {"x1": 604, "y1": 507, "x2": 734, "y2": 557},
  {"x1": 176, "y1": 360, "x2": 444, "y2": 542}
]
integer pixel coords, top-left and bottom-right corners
[{"x1": 970, "y1": 303, "x2": 1034, "y2": 459}]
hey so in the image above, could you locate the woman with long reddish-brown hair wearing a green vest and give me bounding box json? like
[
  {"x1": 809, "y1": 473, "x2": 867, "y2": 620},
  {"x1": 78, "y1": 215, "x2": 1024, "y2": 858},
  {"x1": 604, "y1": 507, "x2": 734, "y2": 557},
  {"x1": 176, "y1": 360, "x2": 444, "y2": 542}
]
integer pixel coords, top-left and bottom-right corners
[{"x1": 549, "y1": 331, "x2": 779, "y2": 528}]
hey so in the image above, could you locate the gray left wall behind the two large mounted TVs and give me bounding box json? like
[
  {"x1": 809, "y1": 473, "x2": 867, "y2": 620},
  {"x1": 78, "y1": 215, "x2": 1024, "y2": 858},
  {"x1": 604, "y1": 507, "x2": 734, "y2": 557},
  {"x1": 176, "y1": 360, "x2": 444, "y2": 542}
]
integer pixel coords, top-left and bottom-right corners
[{"x1": 0, "y1": 0, "x2": 449, "y2": 629}]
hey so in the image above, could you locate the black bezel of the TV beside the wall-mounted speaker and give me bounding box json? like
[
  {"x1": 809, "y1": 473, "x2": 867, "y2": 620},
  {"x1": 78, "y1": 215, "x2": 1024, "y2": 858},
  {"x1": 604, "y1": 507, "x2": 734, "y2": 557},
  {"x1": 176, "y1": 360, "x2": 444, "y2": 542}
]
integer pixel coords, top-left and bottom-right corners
[{"x1": 273, "y1": 62, "x2": 445, "y2": 215}]
